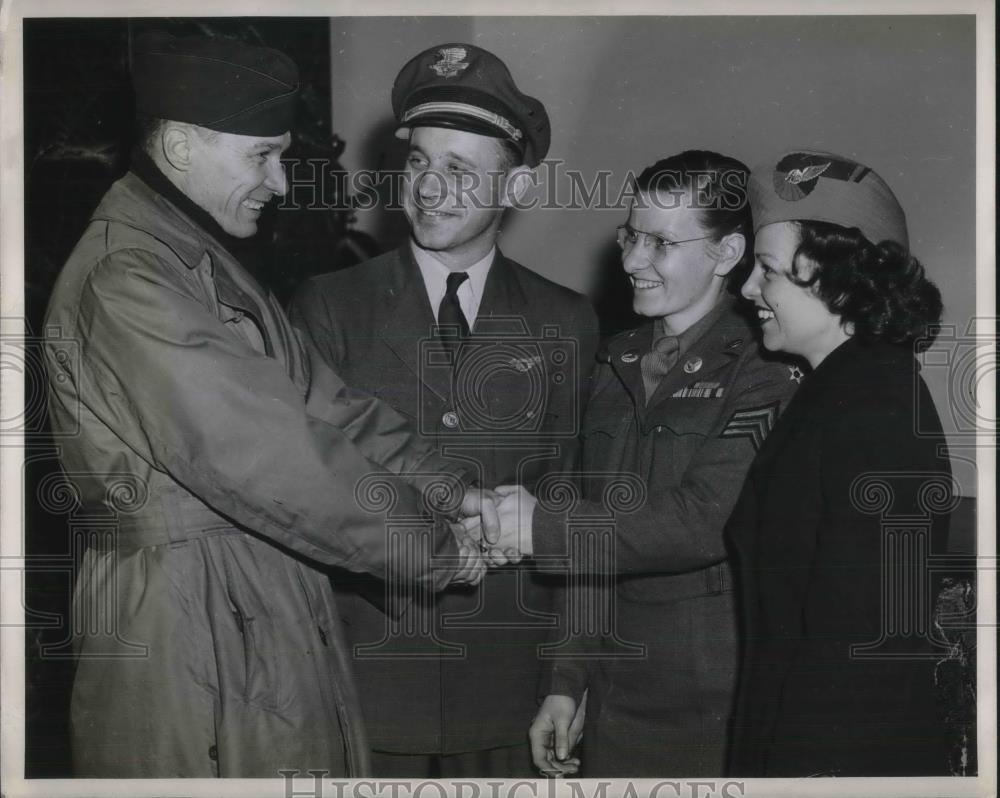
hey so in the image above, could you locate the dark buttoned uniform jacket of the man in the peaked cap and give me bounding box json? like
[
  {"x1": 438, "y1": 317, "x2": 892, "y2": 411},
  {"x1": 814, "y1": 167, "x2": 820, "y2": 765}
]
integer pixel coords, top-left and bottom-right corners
[{"x1": 291, "y1": 246, "x2": 597, "y2": 753}]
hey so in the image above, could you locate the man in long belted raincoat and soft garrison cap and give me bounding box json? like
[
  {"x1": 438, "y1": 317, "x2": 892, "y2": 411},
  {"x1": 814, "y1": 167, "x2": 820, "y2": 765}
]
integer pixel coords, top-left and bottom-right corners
[{"x1": 45, "y1": 34, "x2": 495, "y2": 778}]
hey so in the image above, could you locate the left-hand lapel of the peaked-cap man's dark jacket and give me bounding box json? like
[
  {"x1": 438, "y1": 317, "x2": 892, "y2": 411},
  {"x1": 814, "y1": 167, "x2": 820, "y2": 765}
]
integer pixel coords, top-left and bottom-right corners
[{"x1": 378, "y1": 243, "x2": 451, "y2": 401}]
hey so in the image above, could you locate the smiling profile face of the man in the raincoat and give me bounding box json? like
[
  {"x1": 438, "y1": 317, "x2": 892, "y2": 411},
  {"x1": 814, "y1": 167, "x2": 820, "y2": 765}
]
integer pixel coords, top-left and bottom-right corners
[{"x1": 183, "y1": 128, "x2": 292, "y2": 238}]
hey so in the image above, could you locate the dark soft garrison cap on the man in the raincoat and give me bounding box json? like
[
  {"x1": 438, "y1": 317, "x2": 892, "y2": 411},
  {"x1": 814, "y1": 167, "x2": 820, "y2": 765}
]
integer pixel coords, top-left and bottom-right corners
[{"x1": 132, "y1": 31, "x2": 299, "y2": 136}]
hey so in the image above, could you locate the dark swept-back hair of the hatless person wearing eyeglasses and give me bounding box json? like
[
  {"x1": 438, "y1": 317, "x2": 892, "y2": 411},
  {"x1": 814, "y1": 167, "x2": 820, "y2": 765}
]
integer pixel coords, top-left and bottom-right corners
[{"x1": 635, "y1": 150, "x2": 753, "y2": 296}]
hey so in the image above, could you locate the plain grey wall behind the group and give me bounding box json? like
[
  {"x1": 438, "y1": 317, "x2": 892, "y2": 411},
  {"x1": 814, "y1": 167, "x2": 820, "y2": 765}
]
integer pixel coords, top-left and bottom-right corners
[{"x1": 330, "y1": 16, "x2": 976, "y2": 495}]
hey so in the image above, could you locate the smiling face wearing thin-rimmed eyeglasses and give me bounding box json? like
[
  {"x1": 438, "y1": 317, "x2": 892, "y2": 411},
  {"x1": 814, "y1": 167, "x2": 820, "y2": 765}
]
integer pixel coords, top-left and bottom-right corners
[{"x1": 622, "y1": 192, "x2": 742, "y2": 334}]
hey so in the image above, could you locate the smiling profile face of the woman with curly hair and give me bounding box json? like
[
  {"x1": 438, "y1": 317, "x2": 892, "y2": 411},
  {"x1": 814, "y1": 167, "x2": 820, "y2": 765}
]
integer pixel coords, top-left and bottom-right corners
[{"x1": 741, "y1": 222, "x2": 850, "y2": 368}]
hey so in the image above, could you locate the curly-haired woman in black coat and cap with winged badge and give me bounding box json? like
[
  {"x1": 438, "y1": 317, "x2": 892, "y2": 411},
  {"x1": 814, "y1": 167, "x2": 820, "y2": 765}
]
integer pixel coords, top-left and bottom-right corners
[{"x1": 727, "y1": 151, "x2": 953, "y2": 777}]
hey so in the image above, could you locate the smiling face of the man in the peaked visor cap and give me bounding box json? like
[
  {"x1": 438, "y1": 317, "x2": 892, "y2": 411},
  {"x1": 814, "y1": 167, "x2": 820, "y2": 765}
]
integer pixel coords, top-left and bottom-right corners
[{"x1": 403, "y1": 127, "x2": 506, "y2": 270}]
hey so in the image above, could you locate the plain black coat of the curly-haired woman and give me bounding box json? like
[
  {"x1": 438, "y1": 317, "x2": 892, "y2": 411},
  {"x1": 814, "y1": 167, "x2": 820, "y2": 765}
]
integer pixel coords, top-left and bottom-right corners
[{"x1": 727, "y1": 340, "x2": 951, "y2": 776}]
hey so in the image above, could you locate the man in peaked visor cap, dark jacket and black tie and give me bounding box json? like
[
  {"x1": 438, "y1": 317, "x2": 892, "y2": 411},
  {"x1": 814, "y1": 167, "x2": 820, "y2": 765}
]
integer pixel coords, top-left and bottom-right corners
[{"x1": 291, "y1": 43, "x2": 597, "y2": 777}]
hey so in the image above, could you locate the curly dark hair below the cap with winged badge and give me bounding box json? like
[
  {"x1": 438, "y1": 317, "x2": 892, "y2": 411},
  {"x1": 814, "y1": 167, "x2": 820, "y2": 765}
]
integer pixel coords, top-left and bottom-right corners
[{"x1": 789, "y1": 220, "x2": 942, "y2": 349}]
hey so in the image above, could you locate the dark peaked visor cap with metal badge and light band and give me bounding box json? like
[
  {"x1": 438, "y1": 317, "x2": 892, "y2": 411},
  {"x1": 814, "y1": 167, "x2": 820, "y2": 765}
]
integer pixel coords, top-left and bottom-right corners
[{"x1": 392, "y1": 44, "x2": 551, "y2": 167}]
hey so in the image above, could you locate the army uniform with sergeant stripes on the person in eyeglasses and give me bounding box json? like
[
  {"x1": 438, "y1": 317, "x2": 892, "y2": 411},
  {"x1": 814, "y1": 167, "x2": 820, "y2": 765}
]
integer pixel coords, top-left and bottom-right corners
[{"x1": 533, "y1": 300, "x2": 797, "y2": 777}]
